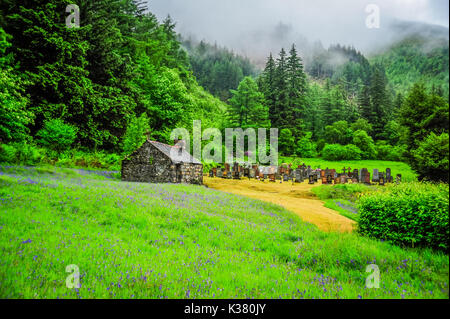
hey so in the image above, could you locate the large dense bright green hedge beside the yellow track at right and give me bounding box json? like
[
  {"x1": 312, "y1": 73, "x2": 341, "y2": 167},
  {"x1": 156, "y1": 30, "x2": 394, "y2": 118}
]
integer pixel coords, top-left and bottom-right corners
[{"x1": 358, "y1": 182, "x2": 449, "y2": 251}]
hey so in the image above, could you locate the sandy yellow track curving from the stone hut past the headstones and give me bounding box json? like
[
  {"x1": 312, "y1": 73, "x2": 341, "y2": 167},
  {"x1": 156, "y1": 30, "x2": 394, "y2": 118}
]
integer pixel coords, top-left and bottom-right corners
[{"x1": 203, "y1": 177, "x2": 356, "y2": 232}]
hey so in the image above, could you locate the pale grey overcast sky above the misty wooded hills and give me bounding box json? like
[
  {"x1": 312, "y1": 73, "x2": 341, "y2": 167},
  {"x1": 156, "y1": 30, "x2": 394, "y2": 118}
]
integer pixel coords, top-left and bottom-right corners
[{"x1": 148, "y1": 0, "x2": 449, "y2": 60}]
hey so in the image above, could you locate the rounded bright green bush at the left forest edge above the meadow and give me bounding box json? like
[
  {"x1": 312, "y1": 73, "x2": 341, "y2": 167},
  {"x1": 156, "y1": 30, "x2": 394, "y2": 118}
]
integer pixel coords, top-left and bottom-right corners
[{"x1": 37, "y1": 119, "x2": 77, "y2": 152}]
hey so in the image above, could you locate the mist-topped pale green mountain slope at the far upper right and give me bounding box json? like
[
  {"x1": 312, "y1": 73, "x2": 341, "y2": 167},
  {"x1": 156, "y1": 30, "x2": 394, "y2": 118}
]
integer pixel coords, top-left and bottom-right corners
[{"x1": 370, "y1": 22, "x2": 449, "y2": 96}]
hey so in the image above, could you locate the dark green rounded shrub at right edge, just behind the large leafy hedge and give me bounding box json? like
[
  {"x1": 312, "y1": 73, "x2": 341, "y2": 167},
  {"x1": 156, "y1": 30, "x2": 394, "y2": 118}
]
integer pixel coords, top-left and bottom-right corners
[{"x1": 411, "y1": 133, "x2": 449, "y2": 183}]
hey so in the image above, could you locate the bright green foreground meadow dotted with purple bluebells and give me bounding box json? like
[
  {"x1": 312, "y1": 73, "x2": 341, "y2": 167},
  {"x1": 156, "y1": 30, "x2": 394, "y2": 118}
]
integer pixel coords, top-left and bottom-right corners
[{"x1": 0, "y1": 166, "x2": 449, "y2": 299}]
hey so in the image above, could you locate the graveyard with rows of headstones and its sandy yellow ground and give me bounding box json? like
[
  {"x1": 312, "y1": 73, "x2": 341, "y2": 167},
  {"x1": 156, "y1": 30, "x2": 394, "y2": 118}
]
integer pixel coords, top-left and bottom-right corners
[{"x1": 204, "y1": 163, "x2": 402, "y2": 232}]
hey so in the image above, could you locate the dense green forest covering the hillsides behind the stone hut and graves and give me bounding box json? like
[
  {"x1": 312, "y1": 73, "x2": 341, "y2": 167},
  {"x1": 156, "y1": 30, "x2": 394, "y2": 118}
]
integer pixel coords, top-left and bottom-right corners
[{"x1": 0, "y1": 0, "x2": 449, "y2": 181}]
